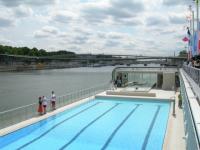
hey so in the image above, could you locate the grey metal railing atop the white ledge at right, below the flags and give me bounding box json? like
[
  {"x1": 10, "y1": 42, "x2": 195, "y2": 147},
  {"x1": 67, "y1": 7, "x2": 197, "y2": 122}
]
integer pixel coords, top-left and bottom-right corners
[{"x1": 183, "y1": 65, "x2": 200, "y2": 87}]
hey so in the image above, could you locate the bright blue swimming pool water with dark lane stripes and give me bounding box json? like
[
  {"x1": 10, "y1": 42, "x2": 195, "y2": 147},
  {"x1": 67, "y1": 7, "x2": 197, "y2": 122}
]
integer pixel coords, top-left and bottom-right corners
[{"x1": 0, "y1": 98, "x2": 170, "y2": 150}]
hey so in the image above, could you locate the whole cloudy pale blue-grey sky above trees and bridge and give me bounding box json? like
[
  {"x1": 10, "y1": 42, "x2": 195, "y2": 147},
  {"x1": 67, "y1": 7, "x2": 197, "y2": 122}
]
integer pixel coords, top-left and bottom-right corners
[{"x1": 0, "y1": 0, "x2": 194, "y2": 56}]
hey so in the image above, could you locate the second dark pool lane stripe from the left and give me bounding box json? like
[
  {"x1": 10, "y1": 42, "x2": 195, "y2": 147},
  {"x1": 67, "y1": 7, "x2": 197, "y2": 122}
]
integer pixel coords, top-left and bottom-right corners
[{"x1": 59, "y1": 103, "x2": 120, "y2": 150}]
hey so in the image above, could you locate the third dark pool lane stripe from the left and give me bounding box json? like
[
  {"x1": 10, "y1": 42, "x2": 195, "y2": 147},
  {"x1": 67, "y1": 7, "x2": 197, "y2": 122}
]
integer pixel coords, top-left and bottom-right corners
[{"x1": 101, "y1": 104, "x2": 142, "y2": 150}]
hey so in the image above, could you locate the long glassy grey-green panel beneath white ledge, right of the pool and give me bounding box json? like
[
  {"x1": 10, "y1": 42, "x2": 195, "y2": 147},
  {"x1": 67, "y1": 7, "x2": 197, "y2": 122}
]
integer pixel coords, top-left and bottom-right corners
[{"x1": 180, "y1": 72, "x2": 200, "y2": 150}]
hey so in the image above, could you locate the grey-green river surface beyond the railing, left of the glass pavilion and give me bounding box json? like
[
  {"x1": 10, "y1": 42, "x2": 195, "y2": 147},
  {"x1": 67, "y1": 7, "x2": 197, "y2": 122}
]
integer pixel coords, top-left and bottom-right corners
[{"x1": 0, "y1": 67, "x2": 113, "y2": 112}]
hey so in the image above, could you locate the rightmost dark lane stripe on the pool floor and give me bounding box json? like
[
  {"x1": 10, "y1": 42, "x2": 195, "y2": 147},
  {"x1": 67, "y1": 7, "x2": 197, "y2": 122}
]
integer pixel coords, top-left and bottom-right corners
[{"x1": 141, "y1": 105, "x2": 161, "y2": 150}]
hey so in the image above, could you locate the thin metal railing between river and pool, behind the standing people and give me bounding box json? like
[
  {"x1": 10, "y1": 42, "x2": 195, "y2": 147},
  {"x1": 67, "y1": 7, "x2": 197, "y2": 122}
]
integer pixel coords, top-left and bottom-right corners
[{"x1": 0, "y1": 83, "x2": 110, "y2": 129}]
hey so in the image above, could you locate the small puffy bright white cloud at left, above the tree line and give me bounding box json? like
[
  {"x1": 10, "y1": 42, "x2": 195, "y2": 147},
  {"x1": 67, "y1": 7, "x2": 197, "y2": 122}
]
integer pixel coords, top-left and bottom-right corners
[{"x1": 34, "y1": 26, "x2": 59, "y2": 38}]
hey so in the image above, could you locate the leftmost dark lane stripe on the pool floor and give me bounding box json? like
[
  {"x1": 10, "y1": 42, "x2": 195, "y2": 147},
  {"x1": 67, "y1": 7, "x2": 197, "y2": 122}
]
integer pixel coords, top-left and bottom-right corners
[{"x1": 16, "y1": 102, "x2": 102, "y2": 150}]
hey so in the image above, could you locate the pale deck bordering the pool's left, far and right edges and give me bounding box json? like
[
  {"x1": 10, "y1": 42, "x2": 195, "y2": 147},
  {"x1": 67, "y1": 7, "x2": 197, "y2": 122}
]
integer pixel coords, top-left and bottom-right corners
[{"x1": 0, "y1": 89, "x2": 186, "y2": 150}]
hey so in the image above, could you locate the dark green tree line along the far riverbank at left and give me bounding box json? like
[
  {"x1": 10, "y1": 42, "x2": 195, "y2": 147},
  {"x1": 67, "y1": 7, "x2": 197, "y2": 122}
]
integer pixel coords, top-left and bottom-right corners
[{"x1": 0, "y1": 45, "x2": 76, "y2": 57}]
